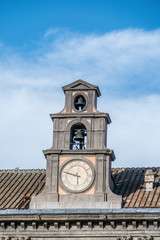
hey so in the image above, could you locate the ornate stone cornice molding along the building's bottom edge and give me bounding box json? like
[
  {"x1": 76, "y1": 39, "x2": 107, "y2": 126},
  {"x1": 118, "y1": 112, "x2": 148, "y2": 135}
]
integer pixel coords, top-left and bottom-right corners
[{"x1": 0, "y1": 213, "x2": 160, "y2": 240}]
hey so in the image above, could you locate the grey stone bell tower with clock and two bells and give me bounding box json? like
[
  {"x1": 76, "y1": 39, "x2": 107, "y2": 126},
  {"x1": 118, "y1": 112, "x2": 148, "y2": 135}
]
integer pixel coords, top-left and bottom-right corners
[{"x1": 30, "y1": 80, "x2": 122, "y2": 209}]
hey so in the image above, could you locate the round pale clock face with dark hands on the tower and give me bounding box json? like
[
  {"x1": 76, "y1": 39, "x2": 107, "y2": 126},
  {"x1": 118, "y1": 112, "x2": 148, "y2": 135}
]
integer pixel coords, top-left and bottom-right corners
[{"x1": 60, "y1": 159, "x2": 94, "y2": 193}]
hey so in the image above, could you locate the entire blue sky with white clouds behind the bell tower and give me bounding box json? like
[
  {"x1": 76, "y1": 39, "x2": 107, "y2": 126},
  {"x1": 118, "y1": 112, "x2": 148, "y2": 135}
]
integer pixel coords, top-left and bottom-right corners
[{"x1": 0, "y1": 0, "x2": 160, "y2": 169}]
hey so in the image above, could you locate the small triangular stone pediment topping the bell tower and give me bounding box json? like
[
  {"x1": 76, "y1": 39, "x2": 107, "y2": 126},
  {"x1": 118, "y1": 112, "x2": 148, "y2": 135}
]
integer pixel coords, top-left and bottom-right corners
[{"x1": 62, "y1": 79, "x2": 101, "y2": 96}]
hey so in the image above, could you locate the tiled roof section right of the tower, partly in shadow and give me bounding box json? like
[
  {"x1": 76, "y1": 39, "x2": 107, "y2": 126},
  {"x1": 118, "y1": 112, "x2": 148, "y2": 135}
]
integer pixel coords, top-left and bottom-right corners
[{"x1": 112, "y1": 168, "x2": 160, "y2": 208}]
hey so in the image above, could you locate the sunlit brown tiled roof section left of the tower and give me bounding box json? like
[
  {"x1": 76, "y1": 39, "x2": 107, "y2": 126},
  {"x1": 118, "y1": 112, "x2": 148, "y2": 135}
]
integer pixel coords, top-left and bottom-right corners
[{"x1": 0, "y1": 169, "x2": 46, "y2": 209}]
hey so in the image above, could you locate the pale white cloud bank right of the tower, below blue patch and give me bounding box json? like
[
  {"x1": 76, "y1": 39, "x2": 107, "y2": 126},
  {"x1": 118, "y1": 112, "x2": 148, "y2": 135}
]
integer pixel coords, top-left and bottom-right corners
[{"x1": 103, "y1": 95, "x2": 160, "y2": 167}]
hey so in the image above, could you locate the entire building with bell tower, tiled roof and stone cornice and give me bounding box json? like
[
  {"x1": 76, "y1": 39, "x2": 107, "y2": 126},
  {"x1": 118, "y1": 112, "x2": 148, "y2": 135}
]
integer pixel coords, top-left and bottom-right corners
[{"x1": 0, "y1": 80, "x2": 160, "y2": 240}]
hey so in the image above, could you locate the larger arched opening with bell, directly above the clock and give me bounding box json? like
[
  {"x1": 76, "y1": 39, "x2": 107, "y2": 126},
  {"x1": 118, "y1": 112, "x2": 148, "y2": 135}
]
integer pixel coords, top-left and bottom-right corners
[{"x1": 70, "y1": 123, "x2": 87, "y2": 149}]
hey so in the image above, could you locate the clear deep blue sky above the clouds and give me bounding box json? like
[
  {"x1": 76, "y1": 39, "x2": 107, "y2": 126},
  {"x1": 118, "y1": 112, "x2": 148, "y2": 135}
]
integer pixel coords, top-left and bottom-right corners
[{"x1": 0, "y1": 0, "x2": 160, "y2": 47}]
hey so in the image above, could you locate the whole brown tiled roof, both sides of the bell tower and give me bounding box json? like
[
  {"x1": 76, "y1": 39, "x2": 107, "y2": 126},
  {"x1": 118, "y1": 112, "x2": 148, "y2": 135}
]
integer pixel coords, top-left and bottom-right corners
[{"x1": 0, "y1": 168, "x2": 160, "y2": 209}]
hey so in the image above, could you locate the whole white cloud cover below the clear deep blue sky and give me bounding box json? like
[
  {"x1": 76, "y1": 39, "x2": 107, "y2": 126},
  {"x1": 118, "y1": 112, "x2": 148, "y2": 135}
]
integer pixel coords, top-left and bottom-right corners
[{"x1": 0, "y1": 29, "x2": 160, "y2": 168}]
